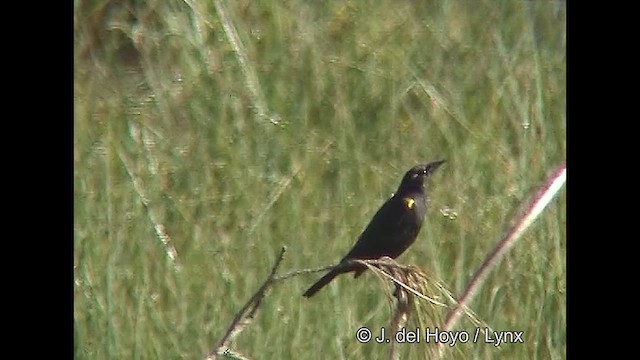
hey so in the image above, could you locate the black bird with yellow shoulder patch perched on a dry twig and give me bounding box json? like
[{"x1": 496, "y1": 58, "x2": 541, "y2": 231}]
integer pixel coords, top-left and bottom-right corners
[{"x1": 304, "y1": 160, "x2": 445, "y2": 297}]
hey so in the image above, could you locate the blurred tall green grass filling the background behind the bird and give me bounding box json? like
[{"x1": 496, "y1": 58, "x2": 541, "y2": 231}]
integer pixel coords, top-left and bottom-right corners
[{"x1": 73, "y1": 0, "x2": 566, "y2": 359}]
